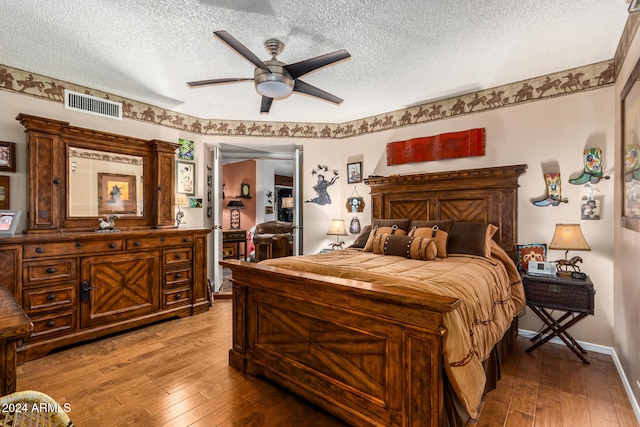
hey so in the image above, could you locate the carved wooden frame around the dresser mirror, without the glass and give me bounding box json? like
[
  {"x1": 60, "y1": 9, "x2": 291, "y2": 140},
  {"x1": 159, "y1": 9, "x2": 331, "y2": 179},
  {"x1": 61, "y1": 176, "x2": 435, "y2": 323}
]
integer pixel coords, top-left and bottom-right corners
[{"x1": 16, "y1": 114, "x2": 179, "y2": 233}]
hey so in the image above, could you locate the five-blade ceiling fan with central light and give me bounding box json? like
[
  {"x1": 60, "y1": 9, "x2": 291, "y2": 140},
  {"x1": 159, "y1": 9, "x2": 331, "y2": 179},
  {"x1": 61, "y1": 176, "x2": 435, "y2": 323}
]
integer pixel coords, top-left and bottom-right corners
[{"x1": 187, "y1": 31, "x2": 351, "y2": 114}]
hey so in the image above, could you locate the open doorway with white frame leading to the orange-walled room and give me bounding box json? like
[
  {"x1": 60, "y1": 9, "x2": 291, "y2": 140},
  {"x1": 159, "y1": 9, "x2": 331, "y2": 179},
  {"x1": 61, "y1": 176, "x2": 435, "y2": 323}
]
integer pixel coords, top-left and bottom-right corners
[{"x1": 209, "y1": 144, "x2": 302, "y2": 298}]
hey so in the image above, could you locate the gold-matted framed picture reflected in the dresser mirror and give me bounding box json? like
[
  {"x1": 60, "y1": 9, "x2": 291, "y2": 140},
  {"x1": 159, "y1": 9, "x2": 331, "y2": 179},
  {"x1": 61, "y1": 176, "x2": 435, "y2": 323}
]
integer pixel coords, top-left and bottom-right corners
[{"x1": 98, "y1": 172, "x2": 138, "y2": 215}]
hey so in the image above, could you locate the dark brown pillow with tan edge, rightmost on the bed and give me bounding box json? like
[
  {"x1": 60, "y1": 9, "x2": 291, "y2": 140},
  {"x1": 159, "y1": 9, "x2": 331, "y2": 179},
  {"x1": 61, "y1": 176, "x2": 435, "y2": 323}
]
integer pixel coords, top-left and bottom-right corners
[{"x1": 447, "y1": 221, "x2": 498, "y2": 258}]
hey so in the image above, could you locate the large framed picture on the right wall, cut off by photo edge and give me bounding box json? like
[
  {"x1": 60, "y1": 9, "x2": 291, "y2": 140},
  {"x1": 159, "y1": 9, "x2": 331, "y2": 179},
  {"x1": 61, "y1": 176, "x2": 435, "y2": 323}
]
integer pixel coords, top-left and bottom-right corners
[{"x1": 620, "y1": 56, "x2": 640, "y2": 231}]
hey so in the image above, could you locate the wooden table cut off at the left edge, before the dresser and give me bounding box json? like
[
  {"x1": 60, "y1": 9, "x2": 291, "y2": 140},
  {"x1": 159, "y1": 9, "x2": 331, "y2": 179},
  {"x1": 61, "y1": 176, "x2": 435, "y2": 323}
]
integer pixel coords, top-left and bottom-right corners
[{"x1": 0, "y1": 286, "x2": 33, "y2": 396}]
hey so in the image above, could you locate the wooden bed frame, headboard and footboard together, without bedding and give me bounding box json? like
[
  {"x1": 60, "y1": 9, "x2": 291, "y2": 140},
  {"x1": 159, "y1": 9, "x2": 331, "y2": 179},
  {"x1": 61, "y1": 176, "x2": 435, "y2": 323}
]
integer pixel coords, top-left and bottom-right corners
[{"x1": 223, "y1": 165, "x2": 527, "y2": 427}]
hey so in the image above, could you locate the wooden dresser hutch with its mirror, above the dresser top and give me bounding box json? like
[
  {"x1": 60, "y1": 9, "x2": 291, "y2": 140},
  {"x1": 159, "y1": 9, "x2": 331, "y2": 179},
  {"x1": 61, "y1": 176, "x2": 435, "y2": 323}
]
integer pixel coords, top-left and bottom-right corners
[{"x1": 16, "y1": 114, "x2": 178, "y2": 233}]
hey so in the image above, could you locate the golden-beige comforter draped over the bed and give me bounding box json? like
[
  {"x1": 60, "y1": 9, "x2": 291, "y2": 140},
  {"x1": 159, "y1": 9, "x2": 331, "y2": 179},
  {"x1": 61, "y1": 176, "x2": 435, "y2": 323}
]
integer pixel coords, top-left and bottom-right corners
[{"x1": 262, "y1": 242, "x2": 525, "y2": 417}]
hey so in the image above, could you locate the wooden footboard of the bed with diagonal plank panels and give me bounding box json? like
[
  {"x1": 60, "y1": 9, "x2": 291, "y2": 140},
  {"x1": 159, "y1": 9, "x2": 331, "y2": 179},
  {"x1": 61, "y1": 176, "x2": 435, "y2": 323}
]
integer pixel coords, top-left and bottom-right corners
[{"x1": 223, "y1": 261, "x2": 460, "y2": 427}]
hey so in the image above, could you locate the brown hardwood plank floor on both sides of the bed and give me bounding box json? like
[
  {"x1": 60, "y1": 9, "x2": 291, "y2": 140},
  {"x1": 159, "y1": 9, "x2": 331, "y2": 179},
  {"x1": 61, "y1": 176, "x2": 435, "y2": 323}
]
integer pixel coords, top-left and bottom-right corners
[{"x1": 18, "y1": 299, "x2": 638, "y2": 427}]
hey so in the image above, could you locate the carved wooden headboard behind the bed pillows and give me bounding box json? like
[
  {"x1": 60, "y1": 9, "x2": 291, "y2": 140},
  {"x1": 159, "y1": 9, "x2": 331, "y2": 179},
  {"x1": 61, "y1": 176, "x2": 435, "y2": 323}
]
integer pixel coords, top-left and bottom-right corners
[{"x1": 365, "y1": 165, "x2": 527, "y2": 260}]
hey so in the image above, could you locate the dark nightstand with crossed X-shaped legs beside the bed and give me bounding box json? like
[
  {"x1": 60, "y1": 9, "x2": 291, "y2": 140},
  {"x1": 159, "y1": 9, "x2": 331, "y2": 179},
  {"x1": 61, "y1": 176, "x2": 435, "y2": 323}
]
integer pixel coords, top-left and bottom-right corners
[{"x1": 522, "y1": 273, "x2": 595, "y2": 364}]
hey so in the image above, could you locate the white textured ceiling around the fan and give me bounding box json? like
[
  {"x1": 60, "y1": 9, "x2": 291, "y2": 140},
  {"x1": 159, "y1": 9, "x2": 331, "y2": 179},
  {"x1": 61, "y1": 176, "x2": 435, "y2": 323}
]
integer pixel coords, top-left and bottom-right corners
[{"x1": 0, "y1": 0, "x2": 628, "y2": 123}]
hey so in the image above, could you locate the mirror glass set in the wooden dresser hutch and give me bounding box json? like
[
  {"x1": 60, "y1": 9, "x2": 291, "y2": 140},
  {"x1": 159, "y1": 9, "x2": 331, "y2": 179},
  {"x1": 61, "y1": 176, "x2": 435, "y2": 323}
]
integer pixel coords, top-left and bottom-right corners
[{"x1": 67, "y1": 147, "x2": 144, "y2": 221}]
